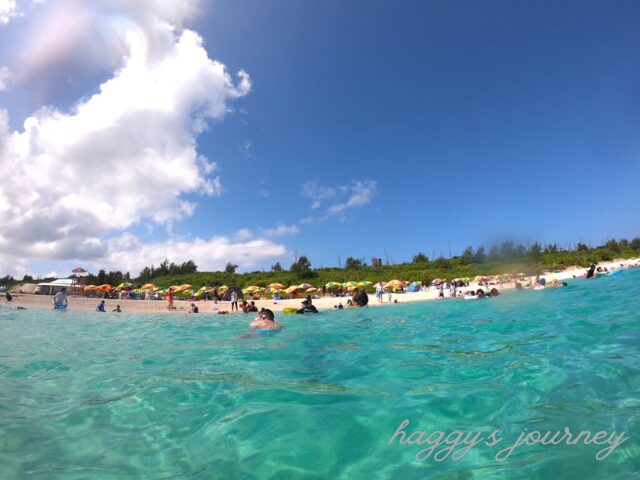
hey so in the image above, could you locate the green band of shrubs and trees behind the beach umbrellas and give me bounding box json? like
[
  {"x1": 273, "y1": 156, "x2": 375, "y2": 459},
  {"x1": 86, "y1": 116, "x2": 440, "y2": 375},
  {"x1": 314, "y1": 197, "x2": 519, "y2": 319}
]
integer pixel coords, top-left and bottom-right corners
[{"x1": 0, "y1": 238, "x2": 640, "y2": 288}]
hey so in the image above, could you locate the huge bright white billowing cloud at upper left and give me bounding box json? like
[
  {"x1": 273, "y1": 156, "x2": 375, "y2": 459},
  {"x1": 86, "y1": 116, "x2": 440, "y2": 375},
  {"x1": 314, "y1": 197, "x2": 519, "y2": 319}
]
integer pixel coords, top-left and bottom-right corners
[{"x1": 0, "y1": 0, "x2": 252, "y2": 272}]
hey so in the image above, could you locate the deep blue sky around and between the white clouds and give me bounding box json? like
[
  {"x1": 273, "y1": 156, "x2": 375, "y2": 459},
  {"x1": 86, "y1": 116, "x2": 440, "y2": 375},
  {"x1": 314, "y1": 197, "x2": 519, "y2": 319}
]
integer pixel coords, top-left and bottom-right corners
[{"x1": 0, "y1": 1, "x2": 640, "y2": 273}]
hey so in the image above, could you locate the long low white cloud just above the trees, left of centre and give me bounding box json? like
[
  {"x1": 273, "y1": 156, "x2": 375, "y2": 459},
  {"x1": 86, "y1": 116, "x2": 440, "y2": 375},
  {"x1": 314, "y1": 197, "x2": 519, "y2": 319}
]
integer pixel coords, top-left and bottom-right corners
[{"x1": 92, "y1": 234, "x2": 287, "y2": 274}]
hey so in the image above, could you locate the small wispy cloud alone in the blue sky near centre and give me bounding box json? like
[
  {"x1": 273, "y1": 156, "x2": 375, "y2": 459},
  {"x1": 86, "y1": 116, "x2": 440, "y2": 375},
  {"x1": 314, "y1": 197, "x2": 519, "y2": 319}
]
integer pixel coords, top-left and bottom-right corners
[{"x1": 300, "y1": 180, "x2": 378, "y2": 219}]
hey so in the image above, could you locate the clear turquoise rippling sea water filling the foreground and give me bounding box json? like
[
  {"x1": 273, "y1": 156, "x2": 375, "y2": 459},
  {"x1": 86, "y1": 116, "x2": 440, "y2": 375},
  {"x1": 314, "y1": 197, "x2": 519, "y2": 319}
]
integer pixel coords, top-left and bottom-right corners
[{"x1": 0, "y1": 270, "x2": 640, "y2": 480}]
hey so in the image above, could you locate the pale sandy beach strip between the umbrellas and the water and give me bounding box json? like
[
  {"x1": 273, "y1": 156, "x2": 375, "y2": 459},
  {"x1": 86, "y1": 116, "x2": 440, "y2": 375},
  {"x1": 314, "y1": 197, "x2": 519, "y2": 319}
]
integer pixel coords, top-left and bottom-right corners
[{"x1": 0, "y1": 259, "x2": 640, "y2": 315}]
